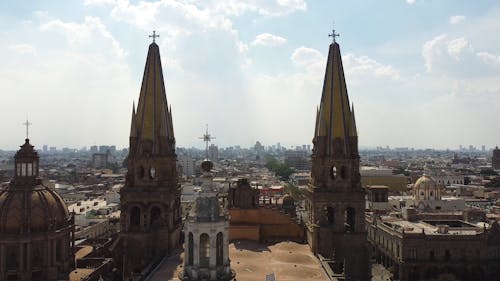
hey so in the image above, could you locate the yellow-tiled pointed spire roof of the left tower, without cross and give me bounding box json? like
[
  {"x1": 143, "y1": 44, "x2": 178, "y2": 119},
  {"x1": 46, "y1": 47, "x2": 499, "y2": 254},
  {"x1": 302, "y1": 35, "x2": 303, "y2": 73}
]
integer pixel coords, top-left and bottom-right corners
[{"x1": 131, "y1": 42, "x2": 174, "y2": 152}]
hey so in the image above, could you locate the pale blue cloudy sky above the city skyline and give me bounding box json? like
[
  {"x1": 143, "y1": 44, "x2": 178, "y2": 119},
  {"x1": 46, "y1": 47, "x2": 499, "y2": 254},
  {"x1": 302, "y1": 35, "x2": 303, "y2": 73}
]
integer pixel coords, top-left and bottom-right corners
[{"x1": 0, "y1": 0, "x2": 500, "y2": 149}]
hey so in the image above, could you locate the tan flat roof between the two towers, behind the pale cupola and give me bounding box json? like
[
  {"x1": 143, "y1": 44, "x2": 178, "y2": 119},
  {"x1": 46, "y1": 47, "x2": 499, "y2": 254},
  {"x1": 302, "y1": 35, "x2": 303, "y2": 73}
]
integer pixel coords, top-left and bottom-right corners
[{"x1": 150, "y1": 241, "x2": 328, "y2": 281}]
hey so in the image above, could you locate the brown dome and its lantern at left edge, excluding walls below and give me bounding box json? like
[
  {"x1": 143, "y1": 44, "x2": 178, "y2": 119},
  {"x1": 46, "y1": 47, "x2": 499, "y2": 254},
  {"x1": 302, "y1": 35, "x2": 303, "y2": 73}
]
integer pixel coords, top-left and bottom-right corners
[{"x1": 0, "y1": 139, "x2": 71, "y2": 234}]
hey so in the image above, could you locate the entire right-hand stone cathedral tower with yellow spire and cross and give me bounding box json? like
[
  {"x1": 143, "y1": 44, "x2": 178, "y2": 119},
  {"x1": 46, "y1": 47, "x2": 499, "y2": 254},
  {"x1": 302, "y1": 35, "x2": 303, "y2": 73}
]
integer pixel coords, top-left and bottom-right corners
[{"x1": 306, "y1": 33, "x2": 370, "y2": 280}]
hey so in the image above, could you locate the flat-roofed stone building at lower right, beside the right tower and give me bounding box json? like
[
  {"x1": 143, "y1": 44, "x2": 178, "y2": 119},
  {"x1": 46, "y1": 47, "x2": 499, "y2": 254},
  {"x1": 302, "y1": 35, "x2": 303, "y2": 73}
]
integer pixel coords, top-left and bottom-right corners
[{"x1": 368, "y1": 215, "x2": 500, "y2": 281}]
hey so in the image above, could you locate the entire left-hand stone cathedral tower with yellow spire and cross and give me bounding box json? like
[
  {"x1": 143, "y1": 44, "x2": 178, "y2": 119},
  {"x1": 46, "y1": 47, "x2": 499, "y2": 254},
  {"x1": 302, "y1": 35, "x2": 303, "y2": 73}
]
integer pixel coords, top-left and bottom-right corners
[{"x1": 120, "y1": 34, "x2": 181, "y2": 280}]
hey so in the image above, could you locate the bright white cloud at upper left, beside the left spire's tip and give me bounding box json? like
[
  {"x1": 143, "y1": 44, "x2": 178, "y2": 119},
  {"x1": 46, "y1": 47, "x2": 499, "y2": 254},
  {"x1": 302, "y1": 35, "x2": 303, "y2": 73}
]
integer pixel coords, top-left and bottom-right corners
[{"x1": 40, "y1": 16, "x2": 126, "y2": 57}]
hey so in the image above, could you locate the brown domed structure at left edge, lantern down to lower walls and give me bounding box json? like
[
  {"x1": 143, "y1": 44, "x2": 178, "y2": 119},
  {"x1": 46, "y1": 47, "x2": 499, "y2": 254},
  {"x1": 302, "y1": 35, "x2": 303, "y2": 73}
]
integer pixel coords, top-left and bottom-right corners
[{"x1": 0, "y1": 139, "x2": 75, "y2": 281}]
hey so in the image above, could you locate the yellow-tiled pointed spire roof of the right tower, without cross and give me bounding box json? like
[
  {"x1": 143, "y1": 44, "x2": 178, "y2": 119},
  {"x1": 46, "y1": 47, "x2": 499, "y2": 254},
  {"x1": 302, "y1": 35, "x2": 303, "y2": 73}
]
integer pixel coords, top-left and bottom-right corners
[{"x1": 314, "y1": 42, "x2": 357, "y2": 153}]
